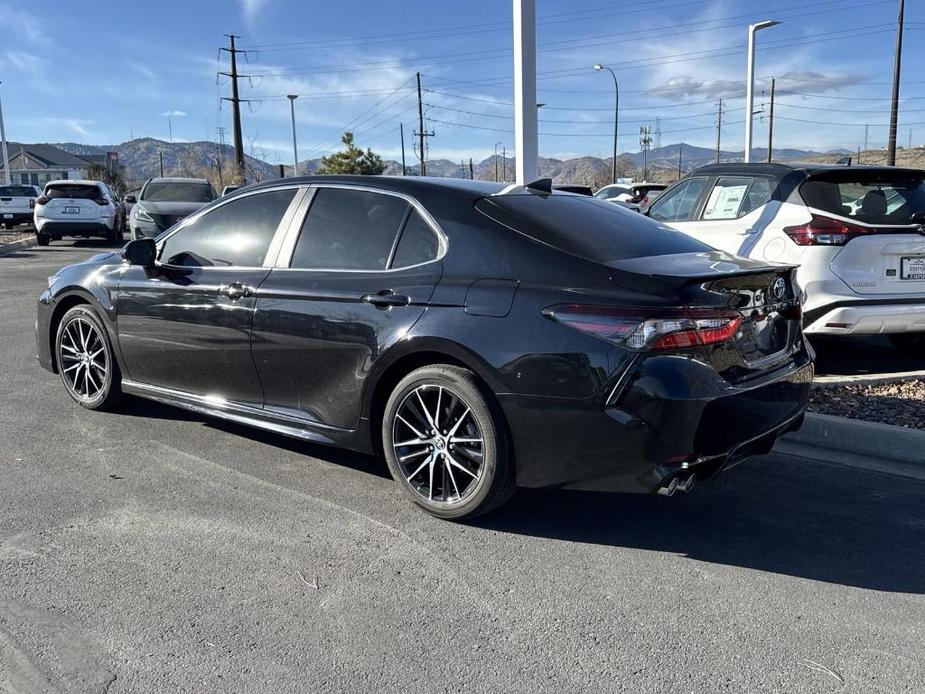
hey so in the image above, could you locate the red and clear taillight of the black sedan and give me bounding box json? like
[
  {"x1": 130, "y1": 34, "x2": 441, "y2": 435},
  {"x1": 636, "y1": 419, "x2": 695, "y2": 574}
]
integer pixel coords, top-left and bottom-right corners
[{"x1": 543, "y1": 304, "x2": 742, "y2": 352}]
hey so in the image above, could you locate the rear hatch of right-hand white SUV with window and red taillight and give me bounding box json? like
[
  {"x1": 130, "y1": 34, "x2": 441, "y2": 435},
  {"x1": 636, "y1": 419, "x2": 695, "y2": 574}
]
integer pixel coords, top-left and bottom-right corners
[{"x1": 785, "y1": 172, "x2": 925, "y2": 296}]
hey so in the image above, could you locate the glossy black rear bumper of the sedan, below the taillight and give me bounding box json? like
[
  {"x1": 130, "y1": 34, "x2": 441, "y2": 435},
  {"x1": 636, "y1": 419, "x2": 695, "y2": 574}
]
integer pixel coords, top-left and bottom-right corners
[{"x1": 499, "y1": 348, "x2": 813, "y2": 493}]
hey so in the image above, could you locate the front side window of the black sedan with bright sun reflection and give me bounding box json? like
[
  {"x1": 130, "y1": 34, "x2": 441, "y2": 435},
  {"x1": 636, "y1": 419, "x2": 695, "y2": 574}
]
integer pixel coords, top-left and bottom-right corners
[{"x1": 161, "y1": 189, "x2": 295, "y2": 267}]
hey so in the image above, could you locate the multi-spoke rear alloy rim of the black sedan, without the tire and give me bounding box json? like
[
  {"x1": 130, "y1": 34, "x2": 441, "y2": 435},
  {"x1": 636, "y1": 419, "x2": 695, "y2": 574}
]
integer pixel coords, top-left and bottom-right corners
[{"x1": 392, "y1": 384, "x2": 484, "y2": 505}]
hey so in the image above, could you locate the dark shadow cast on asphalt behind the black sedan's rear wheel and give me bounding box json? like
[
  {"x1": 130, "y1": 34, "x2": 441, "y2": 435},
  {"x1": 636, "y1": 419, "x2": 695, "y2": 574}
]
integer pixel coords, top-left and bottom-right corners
[{"x1": 475, "y1": 455, "x2": 925, "y2": 593}]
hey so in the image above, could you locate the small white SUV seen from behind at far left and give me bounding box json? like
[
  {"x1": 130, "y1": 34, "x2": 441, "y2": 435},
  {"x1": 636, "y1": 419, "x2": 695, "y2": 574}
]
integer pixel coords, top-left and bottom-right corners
[{"x1": 35, "y1": 181, "x2": 124, "y2": 246}]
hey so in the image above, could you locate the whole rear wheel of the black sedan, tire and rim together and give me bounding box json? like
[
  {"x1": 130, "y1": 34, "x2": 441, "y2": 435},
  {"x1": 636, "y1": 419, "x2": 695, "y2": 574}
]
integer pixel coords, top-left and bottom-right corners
[{"x1": 382, "y1": 364, "x2": 516, "y2": 520}]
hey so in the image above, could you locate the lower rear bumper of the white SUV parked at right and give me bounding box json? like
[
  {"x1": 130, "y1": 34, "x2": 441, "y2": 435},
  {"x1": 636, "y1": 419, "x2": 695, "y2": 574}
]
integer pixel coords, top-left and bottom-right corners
[{"x1": 804, "y1": 297, "x2": 925, "y2": 335}]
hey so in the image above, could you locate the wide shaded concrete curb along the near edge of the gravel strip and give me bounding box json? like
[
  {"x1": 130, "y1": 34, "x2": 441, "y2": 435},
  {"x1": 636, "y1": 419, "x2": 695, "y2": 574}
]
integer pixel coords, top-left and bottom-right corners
[{"x1": 775, "y1": 413, "x2": 925, "y2": 479}]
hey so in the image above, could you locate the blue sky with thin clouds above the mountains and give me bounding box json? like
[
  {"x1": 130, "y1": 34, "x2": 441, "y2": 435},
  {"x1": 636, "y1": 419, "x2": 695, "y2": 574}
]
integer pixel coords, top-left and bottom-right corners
[{"x1": 0, "y1": 0, "x2": 925, "y2": 162}]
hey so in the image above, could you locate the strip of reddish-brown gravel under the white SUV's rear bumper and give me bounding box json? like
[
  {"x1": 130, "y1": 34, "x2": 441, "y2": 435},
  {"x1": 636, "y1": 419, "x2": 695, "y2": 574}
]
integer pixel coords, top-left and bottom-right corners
[{"x1": 810, "y1": 379, "x2": 925, "y2": 429}]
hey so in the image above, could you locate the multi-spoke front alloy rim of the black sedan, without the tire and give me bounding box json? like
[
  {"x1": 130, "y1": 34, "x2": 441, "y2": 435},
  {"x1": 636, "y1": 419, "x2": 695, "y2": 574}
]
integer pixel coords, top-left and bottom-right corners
[{"x1": 59, "y1": 316, "x2": 109, "y2": 402}]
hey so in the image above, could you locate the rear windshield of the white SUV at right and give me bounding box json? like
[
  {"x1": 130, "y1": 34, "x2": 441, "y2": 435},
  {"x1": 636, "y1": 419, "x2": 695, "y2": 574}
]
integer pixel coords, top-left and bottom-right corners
[{"x1": 800, "y1": 172, "x2": 925, "y2": 224}]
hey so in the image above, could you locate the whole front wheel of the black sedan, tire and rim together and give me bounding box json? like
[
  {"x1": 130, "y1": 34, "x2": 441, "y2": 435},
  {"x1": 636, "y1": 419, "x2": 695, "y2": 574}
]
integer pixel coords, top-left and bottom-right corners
[{"x1": 55, "y1": 304, "x2": 122, "y2": 410}]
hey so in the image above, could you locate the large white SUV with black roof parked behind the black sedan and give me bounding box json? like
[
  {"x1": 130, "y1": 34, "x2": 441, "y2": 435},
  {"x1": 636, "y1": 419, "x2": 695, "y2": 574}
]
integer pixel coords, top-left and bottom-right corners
[{"x1": 646, "y1": 164, "x2": 925, "y2": 353}]
